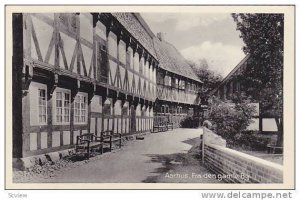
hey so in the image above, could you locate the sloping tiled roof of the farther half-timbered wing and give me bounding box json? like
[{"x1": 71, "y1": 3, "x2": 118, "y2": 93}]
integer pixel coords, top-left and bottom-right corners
[{"x1": 153, "y1": 38, "x2": 201, "y2": 82}]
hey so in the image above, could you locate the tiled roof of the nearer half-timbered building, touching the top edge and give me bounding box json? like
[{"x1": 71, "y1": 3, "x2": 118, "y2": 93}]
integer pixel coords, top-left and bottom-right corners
[{"x1": 111, "y1": 12, "x2": 157, "y2": 59}]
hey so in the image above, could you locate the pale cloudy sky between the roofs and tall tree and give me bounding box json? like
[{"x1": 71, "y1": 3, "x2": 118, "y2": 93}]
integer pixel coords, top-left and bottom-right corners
[{"x1": 141, "y1": 13, "x2": 245, "y2": 77}]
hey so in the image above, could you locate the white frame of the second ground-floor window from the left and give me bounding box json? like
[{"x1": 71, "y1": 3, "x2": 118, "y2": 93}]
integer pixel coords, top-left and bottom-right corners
[{"x1": 52, "y1": 88, "x2": 72, "y2": 125}]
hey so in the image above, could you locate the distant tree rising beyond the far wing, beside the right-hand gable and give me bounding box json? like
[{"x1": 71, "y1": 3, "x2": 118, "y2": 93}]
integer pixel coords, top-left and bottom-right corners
[{"x1": 190, "y1": 59, "x2": 222, "y2": 99}]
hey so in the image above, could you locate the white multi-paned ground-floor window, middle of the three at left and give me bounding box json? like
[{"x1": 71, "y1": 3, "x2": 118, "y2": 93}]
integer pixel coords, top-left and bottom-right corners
[{"x1": 54, "y1": 89, "x2": 71, "y2": 124}]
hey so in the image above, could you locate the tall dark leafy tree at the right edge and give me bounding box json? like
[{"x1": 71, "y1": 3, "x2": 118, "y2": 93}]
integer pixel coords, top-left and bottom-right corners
[{"x1": 232, "y1": 13, "x2": 284, "y2": 146}]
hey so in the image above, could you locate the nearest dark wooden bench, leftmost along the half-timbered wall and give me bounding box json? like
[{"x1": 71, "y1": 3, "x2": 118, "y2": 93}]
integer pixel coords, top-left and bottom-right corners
[{"x1": 75, "y1": 133, "x2": 103, "y2": 159}]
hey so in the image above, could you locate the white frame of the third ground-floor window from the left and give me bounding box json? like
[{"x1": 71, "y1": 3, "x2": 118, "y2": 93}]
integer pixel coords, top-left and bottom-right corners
[{"x1": 73, "y1": 92, "x2": 88, "y2": 124}]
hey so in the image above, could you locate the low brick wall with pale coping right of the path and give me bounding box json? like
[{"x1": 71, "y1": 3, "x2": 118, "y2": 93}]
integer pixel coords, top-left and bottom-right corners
[{"x1": 203, "y1": 128, "x2": 283, "y2": 183}]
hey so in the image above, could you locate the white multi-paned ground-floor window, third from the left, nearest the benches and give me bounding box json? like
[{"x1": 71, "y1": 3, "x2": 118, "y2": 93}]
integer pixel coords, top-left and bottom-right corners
[{"x1": 74, "y1": 94, "x2": 87, "y2": 123}]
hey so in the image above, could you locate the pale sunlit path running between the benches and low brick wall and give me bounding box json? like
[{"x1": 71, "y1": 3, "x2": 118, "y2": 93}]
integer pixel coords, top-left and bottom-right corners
[{"x1": 49, "y1": 129, "x2": 202, "y2": 183}]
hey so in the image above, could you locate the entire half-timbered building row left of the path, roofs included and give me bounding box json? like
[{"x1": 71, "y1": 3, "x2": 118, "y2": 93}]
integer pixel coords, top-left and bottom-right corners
[{"x1": 13, "y1": 13, "x2": 201, "y2": 158}]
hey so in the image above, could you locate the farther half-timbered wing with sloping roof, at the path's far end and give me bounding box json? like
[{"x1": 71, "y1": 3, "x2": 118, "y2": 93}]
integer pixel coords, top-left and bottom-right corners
[{"x1": 154, "y1": 33, "x2": 202, "y2": 127}]
